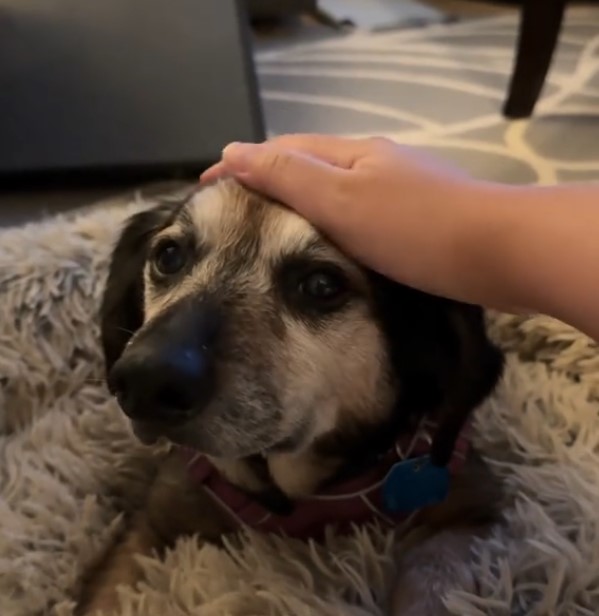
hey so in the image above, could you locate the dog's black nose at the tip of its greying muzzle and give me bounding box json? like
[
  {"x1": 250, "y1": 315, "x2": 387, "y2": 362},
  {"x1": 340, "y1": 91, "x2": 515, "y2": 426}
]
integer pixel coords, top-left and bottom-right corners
[{"x1": 108, "y1": 341, "x2": 210, "y2": 423}]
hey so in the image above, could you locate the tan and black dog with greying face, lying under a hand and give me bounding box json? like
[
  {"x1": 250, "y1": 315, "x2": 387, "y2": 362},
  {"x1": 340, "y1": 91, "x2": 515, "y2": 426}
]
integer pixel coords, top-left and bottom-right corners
[{"x1": 80, "y1": 179, "x2": 503, "y2": 616}]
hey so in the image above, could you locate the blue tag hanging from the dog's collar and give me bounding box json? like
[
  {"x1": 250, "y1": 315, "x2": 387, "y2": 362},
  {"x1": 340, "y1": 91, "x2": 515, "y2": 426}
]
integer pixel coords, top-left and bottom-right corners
[{"x1": 382, "y1": 456, "x2": 449, "y2": 513}]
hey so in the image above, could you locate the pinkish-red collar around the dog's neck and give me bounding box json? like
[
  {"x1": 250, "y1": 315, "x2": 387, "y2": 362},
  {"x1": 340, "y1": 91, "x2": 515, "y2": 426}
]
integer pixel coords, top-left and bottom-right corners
[{"x1": 184, "y1": 421, "x2": 470, "y2": 540}]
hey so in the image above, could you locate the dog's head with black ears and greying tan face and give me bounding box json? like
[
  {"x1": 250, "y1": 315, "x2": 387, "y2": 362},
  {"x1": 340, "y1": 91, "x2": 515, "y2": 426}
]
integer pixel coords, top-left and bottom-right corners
[{"x1": 102, "y1": 180, "x2": 501, "y2": 490}]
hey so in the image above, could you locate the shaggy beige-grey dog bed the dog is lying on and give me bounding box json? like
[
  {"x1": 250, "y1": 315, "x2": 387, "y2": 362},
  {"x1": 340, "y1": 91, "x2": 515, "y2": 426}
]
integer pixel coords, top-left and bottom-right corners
[{"x1": 0, "y1": 194, "x2": 599, "y2": 616}]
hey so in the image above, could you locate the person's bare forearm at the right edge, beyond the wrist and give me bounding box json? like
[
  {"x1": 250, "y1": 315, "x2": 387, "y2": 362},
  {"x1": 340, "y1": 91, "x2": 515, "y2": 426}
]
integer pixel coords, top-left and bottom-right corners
[{"x1": 465, "y1": 184, "x2": 599, "y2": 339}]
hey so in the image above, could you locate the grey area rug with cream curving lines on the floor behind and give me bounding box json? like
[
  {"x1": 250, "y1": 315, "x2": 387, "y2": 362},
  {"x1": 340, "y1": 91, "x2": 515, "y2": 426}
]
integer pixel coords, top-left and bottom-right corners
[{"x1": 259, "y1": 8, "x2": 599, "y2": 183}]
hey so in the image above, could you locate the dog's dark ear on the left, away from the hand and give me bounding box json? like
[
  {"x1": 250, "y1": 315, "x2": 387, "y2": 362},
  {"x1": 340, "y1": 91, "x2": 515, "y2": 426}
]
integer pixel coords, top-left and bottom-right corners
[{"x1": 100, "y1": 203, "x2": 181, "y2": 372}]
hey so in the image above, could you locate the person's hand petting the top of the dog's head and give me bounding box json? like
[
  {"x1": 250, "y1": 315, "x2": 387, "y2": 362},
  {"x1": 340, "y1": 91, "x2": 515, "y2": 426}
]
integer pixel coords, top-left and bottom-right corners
[{"x1": 201, "y1": 135, "x2": 500, "y2": 301}]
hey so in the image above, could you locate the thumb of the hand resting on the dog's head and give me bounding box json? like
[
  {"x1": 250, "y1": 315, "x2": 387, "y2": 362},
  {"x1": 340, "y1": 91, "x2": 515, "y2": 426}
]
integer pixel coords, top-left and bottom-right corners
[{"x1": 222, "y1": 143, "x2": 348, "y2": 225}]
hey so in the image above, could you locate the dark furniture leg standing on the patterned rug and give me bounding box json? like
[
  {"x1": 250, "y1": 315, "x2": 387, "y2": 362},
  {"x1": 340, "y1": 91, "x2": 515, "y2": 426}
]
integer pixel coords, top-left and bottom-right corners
[{"x1": 503, "y1": 0, "x2": 567, "y2": 119}]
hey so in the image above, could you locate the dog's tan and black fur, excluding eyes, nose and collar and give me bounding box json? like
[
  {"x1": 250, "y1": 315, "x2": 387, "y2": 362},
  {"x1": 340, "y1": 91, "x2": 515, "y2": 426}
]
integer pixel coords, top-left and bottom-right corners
[{"x1": 81, "y1": 181, "x2": 502, "y2": 616}]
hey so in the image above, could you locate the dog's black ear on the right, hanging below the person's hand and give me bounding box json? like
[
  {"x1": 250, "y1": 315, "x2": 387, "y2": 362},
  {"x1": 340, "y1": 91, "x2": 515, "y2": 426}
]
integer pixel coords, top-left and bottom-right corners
[{"x1": 369, "y1": 273, "x2": 503, "y2": 466}]
